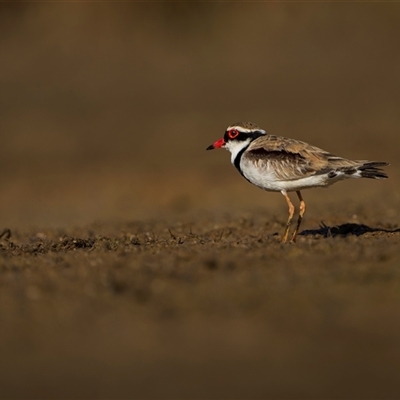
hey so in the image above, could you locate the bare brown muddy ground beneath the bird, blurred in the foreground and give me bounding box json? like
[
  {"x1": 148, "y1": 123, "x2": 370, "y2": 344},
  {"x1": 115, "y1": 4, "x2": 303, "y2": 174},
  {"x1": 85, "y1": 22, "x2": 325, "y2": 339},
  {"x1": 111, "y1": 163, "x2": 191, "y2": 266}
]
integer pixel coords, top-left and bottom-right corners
[{"x1": 0, "y1": 176, "x2": 400, "y2": 398}]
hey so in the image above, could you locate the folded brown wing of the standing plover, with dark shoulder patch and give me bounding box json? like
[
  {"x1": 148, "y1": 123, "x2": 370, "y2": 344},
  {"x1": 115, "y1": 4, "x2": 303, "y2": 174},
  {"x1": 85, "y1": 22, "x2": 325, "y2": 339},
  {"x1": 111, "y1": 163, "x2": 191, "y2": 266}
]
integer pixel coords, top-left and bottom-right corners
[{"x1": 245, "y1": 135, "x2": 359, "y2": 180}]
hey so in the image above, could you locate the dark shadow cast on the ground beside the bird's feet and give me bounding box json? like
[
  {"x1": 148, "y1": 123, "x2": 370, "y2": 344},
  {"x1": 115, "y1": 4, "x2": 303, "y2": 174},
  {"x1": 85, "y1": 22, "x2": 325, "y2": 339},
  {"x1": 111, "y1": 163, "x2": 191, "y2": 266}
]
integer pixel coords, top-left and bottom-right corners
[{"x1": 299, "y1": 223, "x2": 400, "y2": 238}]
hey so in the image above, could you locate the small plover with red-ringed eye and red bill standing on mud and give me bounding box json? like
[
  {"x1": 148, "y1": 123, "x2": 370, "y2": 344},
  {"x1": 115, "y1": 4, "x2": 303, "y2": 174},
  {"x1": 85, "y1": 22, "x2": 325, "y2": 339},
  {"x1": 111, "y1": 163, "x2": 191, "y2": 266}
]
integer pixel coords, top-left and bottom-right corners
[{"x1": 206, "y1": 122, "x2": 389, "y2": 242}]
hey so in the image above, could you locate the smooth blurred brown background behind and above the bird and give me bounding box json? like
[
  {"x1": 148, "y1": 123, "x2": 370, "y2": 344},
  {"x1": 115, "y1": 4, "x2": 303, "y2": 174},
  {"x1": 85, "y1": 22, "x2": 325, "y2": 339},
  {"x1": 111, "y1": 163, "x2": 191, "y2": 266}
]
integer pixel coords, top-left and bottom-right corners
[{"x1": 0, "y1": 2, "x2": 400, "y2": 228}]
